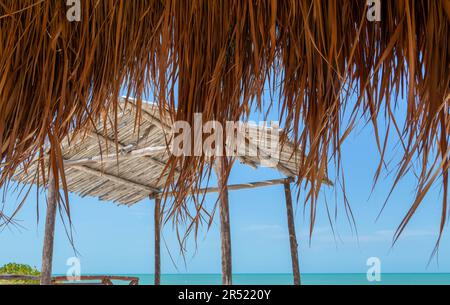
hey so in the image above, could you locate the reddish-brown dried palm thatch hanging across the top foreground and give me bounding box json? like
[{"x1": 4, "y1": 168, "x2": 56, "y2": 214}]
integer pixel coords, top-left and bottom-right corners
[{"x1": 0, "y1": 0, "x2": 450, "y2": 245}]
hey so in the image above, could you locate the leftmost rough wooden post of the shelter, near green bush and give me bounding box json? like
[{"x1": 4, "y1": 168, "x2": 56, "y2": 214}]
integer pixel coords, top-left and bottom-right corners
[{"x1": 41, "y1": 170, "x2": 58, "y2": 285}]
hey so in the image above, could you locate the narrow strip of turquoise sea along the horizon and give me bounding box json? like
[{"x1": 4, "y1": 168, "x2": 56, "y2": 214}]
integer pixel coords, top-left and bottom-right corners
[{"x1": 106, "y1": 273, "x2": 450, "y2": 285}]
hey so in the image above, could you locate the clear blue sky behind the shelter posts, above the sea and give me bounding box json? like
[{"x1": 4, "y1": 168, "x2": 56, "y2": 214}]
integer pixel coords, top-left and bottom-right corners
[{"x1": 0, "y1": 94, "x2": 450, "y2": 274}]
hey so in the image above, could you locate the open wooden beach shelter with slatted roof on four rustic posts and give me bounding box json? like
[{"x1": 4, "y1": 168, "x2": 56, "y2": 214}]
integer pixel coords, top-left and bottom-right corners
[{"x1": 15, "y1": 98, "x2": 330, "y2": 284}]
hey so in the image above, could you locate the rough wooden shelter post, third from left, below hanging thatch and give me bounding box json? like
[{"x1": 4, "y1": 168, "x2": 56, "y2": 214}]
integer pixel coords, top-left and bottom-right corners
[{"x1": 215, "y1": 157, "x2": 233, "y2": 285}]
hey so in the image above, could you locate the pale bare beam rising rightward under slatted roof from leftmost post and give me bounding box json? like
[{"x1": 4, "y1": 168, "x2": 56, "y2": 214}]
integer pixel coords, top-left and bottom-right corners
[{"x1": 64, "y1": 146, "x2": 167, "y2": 167}]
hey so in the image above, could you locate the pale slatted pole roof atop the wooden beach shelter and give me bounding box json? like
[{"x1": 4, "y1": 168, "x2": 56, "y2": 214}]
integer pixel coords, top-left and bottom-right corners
[{"x1": 15, "y1": 99, "x2": 320, "y2": 205}]
